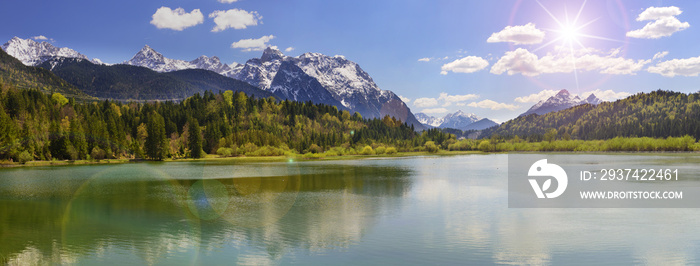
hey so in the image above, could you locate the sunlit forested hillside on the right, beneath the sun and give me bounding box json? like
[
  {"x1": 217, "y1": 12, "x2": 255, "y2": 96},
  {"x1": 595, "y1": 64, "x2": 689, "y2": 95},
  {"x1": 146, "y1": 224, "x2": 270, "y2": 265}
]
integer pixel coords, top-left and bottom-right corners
[{"x1": 481, "y1": 90, "x2": 700, "y2": 141}]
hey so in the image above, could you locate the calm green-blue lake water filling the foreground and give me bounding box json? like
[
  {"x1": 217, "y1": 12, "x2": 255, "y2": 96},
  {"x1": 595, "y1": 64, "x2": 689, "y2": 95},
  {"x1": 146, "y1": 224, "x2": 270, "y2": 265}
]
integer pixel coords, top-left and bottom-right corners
[{"x1": 0, "y1": 154, "x2": 700, "y2": 265}]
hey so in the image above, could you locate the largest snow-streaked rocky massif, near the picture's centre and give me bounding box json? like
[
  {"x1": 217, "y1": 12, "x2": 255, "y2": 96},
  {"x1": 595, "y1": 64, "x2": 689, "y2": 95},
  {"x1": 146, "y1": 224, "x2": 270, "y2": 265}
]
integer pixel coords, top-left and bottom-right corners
[{"x1": 233, "y1": 48, "x2": 423, "y2": 128}]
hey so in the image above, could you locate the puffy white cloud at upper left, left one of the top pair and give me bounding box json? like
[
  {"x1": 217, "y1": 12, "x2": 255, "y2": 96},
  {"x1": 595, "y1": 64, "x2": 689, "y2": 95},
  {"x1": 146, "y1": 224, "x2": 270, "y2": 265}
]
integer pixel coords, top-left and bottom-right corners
[{"x1": 151, "y1": 6, "x2": 204, "y2": 31}]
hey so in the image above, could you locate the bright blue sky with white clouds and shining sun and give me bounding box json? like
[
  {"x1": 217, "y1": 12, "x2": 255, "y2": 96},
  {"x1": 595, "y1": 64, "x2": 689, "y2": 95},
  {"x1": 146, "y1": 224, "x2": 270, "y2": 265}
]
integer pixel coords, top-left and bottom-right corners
[{"x1": 0, "y1": 0, "x2": 700, "y2": 121}]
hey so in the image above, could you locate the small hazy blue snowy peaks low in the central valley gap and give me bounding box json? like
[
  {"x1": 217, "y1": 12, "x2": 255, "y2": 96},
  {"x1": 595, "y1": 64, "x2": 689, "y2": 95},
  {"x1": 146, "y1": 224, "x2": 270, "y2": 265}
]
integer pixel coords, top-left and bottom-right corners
[{"x1": 416, "y1": 110, "x2": 498, "y2": 131}]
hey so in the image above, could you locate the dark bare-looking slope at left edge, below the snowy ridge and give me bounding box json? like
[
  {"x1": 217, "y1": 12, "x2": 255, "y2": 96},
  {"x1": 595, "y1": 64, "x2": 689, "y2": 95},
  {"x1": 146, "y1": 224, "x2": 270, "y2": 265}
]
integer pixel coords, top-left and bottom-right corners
[{"x1": 0, "y1": 49, "x2": 90, "y2": 99}]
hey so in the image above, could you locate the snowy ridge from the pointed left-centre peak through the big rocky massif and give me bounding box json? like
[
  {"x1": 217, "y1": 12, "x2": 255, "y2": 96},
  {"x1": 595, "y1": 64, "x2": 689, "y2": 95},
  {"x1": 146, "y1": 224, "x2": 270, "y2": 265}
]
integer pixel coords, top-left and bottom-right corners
[{"x1": 125, "y1": 46, "x2": 424, "y2": 129}]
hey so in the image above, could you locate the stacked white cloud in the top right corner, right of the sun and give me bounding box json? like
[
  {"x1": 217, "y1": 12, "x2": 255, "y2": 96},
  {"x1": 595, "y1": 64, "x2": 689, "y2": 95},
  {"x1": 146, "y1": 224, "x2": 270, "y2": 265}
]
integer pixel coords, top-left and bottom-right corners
[{"x1": 627, "y1": 6, "x2": 690, "y2": 39}]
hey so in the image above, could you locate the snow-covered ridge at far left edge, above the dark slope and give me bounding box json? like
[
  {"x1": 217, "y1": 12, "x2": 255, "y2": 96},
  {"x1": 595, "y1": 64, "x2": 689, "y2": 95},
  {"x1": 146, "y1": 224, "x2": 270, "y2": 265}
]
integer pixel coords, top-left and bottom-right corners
[{"x1": 2, "y1": 37, "x2": 88, "y2": 66}]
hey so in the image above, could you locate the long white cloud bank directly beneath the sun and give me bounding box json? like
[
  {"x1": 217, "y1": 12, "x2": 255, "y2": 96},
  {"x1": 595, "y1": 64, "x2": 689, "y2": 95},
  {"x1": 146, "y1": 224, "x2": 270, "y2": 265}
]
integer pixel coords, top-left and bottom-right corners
[{"x1": 491, "y1": 48, "x2": 651, "y2": 76}]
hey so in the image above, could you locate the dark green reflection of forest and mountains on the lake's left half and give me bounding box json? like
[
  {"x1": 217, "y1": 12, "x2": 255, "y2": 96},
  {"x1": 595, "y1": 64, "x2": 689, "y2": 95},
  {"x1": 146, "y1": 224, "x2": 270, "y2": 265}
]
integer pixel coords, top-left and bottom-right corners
[{"x1": 0, "y1": 164, "x2": 412, "y2": 264}]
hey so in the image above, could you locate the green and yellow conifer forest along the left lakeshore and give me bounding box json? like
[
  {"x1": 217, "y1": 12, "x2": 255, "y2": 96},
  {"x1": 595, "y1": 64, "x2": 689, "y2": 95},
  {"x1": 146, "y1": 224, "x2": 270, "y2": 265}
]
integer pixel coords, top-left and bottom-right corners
[{"x1": 0, "y1": 84, "x2": 454, "y2": 162}]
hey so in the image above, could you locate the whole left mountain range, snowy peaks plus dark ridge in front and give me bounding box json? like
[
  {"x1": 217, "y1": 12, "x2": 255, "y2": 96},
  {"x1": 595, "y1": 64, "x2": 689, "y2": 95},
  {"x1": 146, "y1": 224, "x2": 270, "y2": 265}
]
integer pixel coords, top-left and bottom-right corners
[{"x1": 2, "y1": 37, "x2": 424, "y2": 130}]
